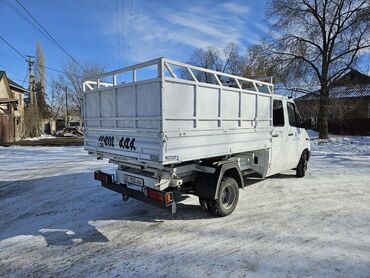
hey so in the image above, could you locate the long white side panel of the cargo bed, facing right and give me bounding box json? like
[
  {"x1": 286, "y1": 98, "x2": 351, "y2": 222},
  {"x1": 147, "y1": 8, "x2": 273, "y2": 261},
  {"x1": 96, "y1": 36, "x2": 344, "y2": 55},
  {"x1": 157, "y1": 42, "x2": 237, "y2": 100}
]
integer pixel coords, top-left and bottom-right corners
[{"x1": 163, "y1": 78, "x2": 272, "y2": 162}]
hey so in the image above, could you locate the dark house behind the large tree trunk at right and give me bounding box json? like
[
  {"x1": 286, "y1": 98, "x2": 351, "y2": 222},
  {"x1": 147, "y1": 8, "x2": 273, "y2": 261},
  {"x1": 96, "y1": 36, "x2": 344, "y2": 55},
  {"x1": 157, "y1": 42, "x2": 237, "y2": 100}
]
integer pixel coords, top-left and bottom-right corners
[{"x1": 295, "y1": 70, "x2": 370, "y2": 135}]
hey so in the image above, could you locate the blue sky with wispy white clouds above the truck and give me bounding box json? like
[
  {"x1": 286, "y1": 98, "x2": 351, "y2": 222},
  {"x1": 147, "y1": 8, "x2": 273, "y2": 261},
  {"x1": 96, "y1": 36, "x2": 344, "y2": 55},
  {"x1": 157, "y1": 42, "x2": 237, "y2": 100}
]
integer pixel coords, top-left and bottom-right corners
[{"x1": 0, "y1": 0, "x2": 267, "y2": 86}]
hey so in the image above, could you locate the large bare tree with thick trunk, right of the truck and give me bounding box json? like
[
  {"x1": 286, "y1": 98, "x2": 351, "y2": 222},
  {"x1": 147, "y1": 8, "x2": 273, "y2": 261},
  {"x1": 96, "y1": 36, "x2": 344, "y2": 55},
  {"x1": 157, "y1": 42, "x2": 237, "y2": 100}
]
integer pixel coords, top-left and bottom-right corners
[{"x1": 267, "y1": 0, "x2": 370, "y2": 138}]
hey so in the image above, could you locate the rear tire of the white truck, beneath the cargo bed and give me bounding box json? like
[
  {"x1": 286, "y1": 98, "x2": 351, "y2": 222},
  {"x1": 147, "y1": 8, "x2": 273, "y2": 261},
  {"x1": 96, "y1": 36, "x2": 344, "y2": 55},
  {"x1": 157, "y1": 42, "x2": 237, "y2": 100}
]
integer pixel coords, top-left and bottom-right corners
[{"x1": 207, "y1": 177, "x2": 239, "y2": 216}]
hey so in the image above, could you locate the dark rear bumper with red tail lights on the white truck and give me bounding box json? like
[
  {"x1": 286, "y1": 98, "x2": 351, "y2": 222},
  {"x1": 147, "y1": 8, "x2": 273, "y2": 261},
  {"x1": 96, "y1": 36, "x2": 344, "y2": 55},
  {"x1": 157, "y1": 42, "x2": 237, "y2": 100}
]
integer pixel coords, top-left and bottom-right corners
[{"x1": 94, "y1": 171, "x2": 176, "y2": 213}]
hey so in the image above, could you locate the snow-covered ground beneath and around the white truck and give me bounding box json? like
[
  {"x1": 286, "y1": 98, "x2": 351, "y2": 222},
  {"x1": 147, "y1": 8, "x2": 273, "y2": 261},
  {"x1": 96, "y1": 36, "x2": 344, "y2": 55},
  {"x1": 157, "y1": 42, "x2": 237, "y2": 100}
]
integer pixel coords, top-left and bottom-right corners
[{"x1": 0, "y1": 137, "x2": 370, "y2": 277}]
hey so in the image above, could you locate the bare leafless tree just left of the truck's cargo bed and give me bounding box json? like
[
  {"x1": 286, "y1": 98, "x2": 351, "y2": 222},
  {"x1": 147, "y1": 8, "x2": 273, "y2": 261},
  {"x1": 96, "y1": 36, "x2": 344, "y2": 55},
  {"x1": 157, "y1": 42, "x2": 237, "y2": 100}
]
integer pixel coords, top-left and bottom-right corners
[{"x1": 57, "y1": 60, "x2": 104, "y2": 113}]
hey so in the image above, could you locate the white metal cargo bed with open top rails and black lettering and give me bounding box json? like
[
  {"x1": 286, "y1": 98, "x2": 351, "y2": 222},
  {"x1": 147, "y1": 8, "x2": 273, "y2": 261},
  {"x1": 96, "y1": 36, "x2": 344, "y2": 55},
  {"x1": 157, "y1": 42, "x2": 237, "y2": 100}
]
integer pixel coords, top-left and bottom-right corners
[{"x1": 83, "y1": 58, "x2": 273, "y2": 165}]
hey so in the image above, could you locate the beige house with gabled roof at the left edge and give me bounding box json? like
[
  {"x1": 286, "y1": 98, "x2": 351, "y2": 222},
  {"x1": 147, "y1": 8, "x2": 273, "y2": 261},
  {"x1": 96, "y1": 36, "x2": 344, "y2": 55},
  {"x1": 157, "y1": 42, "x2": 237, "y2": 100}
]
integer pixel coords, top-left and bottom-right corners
[{"x1": 0, "y1": 71, "x2": 27, "y2": 143}]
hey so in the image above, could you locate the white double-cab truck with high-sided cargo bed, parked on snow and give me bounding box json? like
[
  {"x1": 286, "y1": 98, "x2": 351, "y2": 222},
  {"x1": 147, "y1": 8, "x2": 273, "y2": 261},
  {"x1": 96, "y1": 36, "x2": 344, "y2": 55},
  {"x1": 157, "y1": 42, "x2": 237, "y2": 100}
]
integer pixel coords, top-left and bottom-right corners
[{"x1": 83, "y1": 58, "x2": 310, "y2": 216}]
